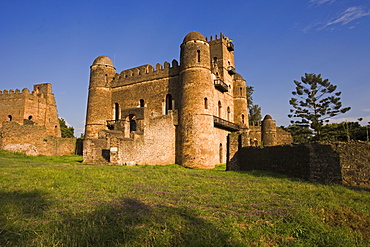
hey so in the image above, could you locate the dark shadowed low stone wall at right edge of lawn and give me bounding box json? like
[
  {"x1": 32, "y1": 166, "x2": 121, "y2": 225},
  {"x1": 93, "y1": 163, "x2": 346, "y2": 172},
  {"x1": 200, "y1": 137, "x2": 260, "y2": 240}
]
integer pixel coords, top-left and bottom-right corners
[{"x1": 227, "y1": 142, "x2": 370, "y2": 186}]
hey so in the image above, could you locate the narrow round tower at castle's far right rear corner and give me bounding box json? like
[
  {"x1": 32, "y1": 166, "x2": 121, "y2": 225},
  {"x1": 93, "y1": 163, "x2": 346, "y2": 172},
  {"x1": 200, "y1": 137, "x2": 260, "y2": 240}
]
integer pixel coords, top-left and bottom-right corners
[{"x1": 233, "y1": 73, "x2": 249, "y2": 129}]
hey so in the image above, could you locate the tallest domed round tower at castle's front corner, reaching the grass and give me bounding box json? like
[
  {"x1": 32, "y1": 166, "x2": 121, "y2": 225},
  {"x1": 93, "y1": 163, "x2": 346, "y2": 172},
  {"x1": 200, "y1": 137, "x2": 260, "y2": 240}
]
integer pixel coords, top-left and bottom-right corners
[{"x1": 177, "y1": 32, "x2": 218, "y2": 168}]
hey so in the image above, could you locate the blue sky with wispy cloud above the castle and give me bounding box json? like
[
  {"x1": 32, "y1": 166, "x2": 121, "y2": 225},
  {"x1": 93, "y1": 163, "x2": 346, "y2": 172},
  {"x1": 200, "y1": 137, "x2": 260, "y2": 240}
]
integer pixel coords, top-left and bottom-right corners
[{"x1": 0, "y1": 0, "x2": 370, "y2": 136}]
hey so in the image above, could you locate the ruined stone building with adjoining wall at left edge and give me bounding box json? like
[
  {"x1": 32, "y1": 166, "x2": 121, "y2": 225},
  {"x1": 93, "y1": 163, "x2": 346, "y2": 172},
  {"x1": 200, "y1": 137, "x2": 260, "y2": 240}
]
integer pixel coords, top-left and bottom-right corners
[{"x1": 0, "y1": 83, "x2": 76, "y2": 155}]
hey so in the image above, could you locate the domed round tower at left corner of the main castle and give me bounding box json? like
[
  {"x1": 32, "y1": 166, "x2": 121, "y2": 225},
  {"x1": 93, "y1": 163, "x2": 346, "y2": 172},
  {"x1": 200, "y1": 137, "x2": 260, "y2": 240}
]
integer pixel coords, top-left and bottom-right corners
[{"x1": 85, "y1": 56, "x2": 116, "y2": 139}]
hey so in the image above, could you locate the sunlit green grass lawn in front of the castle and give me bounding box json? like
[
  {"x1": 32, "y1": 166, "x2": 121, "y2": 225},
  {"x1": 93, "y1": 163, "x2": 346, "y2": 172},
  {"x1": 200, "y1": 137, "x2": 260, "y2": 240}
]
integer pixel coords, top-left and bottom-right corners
[{"x1": 0, "y1": 151, "x2": 370, "y2": 247}]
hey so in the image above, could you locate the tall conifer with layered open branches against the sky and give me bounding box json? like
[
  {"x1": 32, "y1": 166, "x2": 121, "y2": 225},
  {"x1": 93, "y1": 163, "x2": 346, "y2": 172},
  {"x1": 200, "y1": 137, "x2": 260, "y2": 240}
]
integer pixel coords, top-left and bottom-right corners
[{"x1": 288, "y1": 73, "x2": 351, "y2": 140}]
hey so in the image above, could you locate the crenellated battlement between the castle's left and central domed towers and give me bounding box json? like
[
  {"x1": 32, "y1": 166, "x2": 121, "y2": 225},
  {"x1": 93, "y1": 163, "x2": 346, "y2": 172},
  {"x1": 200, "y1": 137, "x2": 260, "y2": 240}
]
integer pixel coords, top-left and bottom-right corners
[{"x1": 112, "y1": 59, "x2": 180, "y2": 87}]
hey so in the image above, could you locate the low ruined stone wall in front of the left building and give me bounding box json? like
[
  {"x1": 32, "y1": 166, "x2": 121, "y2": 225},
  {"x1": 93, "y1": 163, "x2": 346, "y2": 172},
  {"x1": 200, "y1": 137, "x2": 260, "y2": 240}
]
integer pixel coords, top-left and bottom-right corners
[{"x1": 0, "y1": 121, "x2": 76, "y2": 156}]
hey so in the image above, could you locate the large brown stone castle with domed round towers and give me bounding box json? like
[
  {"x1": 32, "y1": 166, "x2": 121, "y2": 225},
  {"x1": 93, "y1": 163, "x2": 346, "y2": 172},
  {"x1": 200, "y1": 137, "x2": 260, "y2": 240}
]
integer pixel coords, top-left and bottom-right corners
[{"x1": 83, "y1": 32, "x2": 292, "y2": 168}]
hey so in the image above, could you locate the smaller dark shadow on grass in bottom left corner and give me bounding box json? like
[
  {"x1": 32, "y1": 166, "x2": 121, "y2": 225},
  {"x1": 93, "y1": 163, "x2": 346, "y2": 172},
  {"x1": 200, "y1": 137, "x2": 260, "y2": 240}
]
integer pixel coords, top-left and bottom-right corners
[{"x1": 0, "y1": 190, "x2": 48, "y2": 246}]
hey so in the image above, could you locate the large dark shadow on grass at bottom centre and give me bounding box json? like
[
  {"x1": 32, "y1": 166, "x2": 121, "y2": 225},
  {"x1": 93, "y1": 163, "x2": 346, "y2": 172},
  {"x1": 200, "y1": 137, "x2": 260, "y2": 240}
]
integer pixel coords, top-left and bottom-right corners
[{"x1": 52, "y1": 198, "x2": 242, "y2": 246}]
